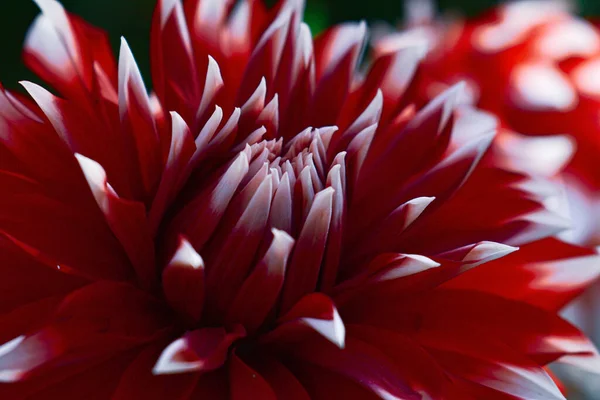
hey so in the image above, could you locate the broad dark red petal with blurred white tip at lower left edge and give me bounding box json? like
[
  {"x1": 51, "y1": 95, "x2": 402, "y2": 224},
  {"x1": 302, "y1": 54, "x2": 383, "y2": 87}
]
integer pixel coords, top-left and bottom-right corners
[{"x1": 0, "y1": 282, "x2": 170, "y2": 382}]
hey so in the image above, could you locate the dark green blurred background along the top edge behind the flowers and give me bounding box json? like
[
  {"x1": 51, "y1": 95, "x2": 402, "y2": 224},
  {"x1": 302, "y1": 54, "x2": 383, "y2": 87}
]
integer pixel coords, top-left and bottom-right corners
[{"x1": 0, "y1": 0, "x2": 600, "y2": 87}]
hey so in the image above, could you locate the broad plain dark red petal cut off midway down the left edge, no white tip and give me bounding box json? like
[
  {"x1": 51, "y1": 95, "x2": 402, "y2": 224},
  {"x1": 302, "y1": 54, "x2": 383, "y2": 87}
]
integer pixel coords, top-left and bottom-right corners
[{"x1": 0, "y1": 171, "x2": 131, "y2": 280}]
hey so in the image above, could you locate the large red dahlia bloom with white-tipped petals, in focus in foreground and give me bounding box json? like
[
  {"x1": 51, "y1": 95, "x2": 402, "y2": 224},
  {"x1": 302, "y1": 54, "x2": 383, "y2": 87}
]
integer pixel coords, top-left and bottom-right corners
[{"x1": 0, "y1": 0, "x2": 598, "y2": 400}]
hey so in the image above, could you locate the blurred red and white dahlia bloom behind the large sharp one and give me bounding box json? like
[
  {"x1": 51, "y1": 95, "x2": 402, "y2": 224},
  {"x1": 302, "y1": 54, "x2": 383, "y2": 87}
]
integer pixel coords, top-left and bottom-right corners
[{"x1": 376, "y1": 0, "x2": 600, "y2": 245}]
